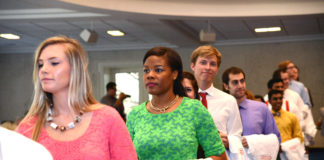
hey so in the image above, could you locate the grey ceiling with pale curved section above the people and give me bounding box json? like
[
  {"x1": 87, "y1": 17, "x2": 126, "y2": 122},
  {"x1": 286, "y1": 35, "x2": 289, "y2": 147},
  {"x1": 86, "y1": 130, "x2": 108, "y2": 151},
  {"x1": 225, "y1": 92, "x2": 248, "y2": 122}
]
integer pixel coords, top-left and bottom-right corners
[{"x1": 0, "y1": 0, "x2": 324, "y2": 54}]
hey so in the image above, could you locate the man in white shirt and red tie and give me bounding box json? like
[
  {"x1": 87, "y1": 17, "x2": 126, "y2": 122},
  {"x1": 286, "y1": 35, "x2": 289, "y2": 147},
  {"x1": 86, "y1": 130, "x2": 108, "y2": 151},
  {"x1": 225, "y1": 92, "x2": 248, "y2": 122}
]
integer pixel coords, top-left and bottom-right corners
[{"x1": 190, "y1": 46, "x2": 242, "y2": 157}]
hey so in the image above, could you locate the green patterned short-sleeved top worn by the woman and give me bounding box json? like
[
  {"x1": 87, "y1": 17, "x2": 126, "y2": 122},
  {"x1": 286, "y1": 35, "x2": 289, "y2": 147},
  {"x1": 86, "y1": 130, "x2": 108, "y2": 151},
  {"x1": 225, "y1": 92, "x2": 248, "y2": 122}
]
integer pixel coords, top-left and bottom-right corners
[{"x1": 126, "y1": 97, "x2": 225, "y2": 160}]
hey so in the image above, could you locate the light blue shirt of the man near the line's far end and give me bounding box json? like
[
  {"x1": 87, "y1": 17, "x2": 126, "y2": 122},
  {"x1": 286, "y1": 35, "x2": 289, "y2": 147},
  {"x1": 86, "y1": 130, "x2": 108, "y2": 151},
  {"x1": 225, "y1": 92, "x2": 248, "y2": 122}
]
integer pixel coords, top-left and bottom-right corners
[{"x1": 289, "y1": 80, "x2": 312, "y2": 107}]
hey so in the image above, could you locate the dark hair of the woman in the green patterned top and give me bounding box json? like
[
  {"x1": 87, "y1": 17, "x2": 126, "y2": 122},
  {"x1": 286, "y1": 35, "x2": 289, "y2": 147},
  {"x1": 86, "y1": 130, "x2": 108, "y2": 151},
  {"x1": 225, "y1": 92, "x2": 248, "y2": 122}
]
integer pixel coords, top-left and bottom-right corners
[{"x1": 143, "y1": 47, "x2": 186, "y2": 97}]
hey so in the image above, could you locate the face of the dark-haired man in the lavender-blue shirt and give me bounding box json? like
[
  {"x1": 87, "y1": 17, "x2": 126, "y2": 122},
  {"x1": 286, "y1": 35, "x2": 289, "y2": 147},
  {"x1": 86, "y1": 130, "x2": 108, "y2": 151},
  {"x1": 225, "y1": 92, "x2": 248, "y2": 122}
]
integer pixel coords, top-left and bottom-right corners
[{"x1": 224, "y1": 73, "x2": 246, "y2": 99}]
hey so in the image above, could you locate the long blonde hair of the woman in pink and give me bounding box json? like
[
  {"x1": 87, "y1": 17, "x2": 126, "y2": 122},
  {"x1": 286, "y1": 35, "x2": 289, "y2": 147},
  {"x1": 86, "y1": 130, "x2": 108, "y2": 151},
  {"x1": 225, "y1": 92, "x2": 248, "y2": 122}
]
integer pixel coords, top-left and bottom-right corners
[{"x1": 19, "y1": 36, "x2": 97, "y2": 141}]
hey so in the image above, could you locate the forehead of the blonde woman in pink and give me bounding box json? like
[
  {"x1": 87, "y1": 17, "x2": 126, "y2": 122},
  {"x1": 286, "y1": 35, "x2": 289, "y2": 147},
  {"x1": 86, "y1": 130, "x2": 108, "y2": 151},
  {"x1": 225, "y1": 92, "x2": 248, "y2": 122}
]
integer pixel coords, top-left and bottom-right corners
[{"x1": 39, "y1": 44, "x2": 66, "y2": 60}]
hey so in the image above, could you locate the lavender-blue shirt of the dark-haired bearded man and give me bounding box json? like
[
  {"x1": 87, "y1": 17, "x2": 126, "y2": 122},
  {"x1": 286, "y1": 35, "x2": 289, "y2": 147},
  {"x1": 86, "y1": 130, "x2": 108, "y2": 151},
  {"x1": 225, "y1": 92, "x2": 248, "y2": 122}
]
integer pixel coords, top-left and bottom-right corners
[{"x1": 239, "y1": 99, "x2": 281, "y2": 143}]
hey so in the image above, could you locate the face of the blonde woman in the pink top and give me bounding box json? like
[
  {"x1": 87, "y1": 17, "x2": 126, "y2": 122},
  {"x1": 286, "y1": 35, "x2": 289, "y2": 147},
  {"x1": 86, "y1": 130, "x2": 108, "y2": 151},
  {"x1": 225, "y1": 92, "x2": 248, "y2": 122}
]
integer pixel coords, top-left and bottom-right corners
[{"x1": 38, "y1": 44, "x2": 70, "y2": 94}]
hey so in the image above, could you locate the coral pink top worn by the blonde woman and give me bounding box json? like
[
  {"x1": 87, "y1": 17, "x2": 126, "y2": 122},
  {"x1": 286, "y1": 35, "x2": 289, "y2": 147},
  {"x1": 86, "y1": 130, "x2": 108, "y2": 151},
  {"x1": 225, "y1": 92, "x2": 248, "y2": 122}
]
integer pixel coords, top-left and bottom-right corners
[{"x1": 18, "y1": 107, "x2": 137, "y2": 160}]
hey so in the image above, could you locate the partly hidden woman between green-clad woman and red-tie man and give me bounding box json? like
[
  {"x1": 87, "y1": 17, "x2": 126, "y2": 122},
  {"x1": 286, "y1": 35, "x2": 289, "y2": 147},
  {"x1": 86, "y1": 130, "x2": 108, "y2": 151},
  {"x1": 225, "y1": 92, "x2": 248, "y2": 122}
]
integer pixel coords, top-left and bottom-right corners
[{"x1": 182, "y1": 71, "x2": 200, "y2": 100}]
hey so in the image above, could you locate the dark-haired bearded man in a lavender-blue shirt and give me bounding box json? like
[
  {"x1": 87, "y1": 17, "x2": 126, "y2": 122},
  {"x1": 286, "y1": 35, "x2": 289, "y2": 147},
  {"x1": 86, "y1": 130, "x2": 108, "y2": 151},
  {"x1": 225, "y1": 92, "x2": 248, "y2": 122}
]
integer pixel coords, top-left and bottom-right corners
[{"x1": 222, "y1": 67, "x2": 281, "y2": 154}]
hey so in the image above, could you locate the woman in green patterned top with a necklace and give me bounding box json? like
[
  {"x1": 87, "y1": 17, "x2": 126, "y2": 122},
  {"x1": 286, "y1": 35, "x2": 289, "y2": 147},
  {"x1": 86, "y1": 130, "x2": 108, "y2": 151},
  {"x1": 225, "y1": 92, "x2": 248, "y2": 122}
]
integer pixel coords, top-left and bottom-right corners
[{"x1": 126, "y1": 47, "x2": 226, "y2": 160}]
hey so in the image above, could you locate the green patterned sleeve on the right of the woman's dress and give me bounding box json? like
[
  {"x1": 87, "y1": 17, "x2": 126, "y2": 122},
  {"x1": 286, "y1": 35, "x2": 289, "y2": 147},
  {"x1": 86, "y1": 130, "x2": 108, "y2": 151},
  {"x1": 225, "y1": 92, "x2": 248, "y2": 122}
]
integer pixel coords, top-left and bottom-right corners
[{"x1": 196, "y1": 104, "x2": 225, "y2": 157}]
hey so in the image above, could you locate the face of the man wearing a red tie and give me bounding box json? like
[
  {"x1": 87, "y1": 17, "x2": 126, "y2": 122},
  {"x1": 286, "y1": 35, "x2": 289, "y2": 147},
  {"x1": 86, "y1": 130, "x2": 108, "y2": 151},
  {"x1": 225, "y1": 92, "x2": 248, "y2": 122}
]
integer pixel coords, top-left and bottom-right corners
[{"x1": 191, "y1": 56, "x2": 218, "y2": 85}]
